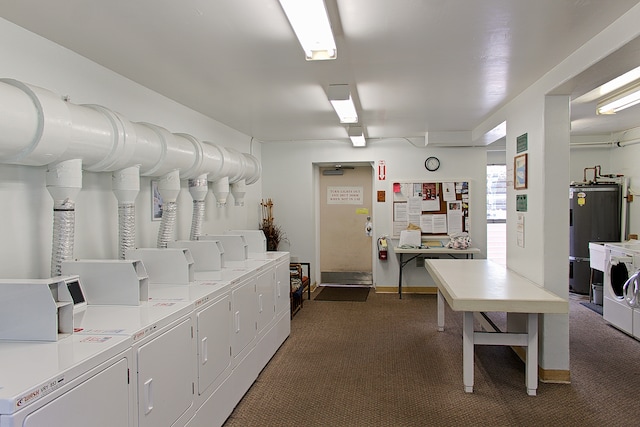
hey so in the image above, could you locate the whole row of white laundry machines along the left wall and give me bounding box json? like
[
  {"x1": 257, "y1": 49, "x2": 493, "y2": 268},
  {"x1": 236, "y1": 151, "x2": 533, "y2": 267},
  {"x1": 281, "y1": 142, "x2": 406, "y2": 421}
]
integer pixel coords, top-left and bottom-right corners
[{"x1": 0, "y1": 252, "x2": 290, "y2": 427}]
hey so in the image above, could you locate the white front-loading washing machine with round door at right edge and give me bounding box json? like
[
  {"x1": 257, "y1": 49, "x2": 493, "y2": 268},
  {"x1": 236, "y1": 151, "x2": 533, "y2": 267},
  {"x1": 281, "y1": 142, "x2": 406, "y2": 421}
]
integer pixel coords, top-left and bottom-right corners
[{"x1": 602, "y1": 243, "x2": 640, "y2": 335}]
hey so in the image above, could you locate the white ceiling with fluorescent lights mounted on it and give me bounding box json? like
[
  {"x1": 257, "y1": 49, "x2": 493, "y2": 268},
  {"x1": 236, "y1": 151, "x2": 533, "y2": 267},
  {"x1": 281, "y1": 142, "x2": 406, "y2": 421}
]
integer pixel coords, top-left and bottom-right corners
[{"x1": 0, "y1": 0, "x2": 640, "y2": 145}]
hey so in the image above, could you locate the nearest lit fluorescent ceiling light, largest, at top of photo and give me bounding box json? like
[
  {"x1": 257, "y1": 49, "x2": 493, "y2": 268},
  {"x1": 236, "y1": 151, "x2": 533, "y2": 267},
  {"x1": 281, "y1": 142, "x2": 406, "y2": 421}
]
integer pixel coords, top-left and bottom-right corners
[{"x1": 280, "y1": 0, "x2": 338, "y2": 61}]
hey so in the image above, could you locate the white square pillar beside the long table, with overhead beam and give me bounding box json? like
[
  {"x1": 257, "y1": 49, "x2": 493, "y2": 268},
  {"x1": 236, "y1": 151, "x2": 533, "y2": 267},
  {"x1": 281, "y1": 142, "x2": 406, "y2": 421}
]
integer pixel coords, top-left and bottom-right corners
[{"x1": 478, "y1": 1, "x2": 640, "y2": 371}]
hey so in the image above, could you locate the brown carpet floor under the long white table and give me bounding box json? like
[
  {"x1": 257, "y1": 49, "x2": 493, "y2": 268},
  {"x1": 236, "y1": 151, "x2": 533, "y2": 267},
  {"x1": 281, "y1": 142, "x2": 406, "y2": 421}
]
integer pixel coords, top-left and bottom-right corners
[{"x1": 225, "y1": 291, "x2": 640, "y2": 427}]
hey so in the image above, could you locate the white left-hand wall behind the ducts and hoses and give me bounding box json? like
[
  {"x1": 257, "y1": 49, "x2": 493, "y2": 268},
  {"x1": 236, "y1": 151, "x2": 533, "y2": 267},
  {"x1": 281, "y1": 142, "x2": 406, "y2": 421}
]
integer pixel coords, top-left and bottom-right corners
[{"x1": 0, "y1": 19, "x2": 262, "y2": 278}]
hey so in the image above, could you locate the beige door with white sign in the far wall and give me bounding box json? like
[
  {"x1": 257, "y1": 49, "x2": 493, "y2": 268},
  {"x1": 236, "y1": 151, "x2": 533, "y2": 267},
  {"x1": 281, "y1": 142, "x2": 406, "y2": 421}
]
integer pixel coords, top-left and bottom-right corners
[{"x1": 318, "y1": 166, "x2": 373, "y2": 286}]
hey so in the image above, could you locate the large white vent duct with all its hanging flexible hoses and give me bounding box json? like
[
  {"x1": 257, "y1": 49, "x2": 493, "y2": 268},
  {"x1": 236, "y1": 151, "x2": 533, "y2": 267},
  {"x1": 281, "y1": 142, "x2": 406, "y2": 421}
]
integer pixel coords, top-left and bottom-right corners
[{"x1": 0, "y1": 79, "x2": 262, "y2": 264}]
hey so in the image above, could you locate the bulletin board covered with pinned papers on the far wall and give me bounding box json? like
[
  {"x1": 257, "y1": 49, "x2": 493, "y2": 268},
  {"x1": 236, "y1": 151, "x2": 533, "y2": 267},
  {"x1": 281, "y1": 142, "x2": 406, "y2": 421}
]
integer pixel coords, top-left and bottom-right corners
[{"x1": 392, "y1": 181, "x2": 469, "y2": 238}]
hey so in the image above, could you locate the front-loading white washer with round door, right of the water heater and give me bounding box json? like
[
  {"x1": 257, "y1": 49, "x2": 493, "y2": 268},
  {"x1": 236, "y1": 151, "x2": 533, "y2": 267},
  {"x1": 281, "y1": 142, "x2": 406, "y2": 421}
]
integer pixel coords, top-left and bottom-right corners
[{"x1": 602, "y1": 241, "x2": 640, "y2": 339}]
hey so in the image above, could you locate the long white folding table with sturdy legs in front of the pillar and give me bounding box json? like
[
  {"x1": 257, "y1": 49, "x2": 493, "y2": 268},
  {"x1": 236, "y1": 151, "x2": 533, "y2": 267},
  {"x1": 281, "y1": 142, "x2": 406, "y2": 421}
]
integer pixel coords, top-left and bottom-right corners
[{"x1": 425, "y1": 259, "x2": 569, "y2": 396}]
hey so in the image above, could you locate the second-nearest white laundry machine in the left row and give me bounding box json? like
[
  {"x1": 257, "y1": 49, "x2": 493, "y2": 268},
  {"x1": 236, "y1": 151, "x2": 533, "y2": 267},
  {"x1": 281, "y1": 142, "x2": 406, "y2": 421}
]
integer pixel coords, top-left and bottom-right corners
[{"x1": 74, "y1": 301, "x2": 196, "y2": 427}]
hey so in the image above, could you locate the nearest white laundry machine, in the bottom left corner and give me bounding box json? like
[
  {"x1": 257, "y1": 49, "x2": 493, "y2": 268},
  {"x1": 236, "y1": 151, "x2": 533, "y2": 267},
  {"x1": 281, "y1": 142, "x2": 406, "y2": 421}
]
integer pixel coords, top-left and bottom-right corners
[{"x1": 0, "y1": 334, "x2": 136, "y2": 427}]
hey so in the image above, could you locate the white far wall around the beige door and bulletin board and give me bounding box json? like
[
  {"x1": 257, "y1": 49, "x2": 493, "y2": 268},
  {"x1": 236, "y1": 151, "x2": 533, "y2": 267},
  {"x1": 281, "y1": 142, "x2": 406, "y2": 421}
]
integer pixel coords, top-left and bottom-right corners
[{"x1": 262, "y1": 138, "x2": 487, "y2": 286}]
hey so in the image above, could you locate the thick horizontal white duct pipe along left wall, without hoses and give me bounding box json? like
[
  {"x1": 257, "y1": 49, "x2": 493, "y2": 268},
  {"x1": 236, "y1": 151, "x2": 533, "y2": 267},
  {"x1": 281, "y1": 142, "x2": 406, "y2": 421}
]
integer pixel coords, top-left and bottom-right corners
[{"x1": 0, "y1": 79, "x2": 261, "y2": 185}]
